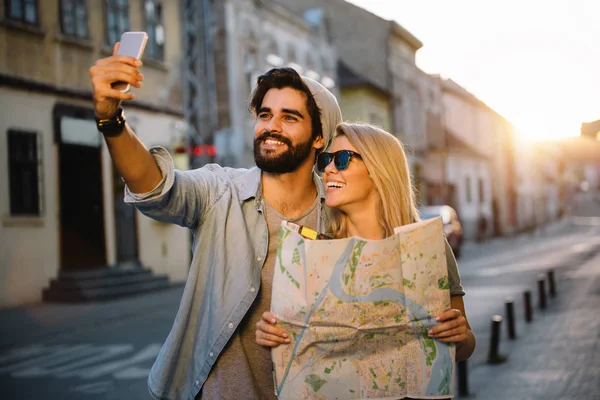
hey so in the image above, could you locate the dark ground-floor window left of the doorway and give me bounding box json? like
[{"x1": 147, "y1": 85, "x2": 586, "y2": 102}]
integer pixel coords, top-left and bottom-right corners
[{"x1": 8, "y1": 130, "x2": 41, "y2": 216}]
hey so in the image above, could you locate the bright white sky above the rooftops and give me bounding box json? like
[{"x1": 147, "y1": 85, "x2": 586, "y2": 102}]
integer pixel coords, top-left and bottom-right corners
[{"x1": 349, "y1": 0, "x2": 600, "y2": 139}]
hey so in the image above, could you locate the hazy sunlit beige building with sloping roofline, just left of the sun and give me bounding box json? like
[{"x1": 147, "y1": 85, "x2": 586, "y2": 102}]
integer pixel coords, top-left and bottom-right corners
[{"x1": 439, "y1": 79, "x2": 516, "y2": 239}]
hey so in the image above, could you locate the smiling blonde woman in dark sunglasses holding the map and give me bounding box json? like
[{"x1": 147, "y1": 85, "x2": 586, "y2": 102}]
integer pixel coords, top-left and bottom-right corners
[{"x1": 256, "y1": 123, "x2": 475, "y2": 361}]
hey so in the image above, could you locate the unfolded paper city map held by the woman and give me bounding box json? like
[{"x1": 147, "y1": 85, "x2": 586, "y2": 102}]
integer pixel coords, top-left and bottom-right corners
[{"x1": 271, "y1": 218, "x2": 455, "y2": 400}]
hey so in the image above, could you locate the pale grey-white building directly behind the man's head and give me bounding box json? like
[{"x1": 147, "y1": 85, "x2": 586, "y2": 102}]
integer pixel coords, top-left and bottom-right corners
[{"x1": 209, "y1": 0, "x2": 338, "y2": 167}]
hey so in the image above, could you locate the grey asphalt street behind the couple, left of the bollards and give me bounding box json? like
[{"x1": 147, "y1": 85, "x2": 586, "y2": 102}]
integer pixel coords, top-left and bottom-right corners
[{"x1": 0, "y1": 192, "x2": 600, "y2": 399}]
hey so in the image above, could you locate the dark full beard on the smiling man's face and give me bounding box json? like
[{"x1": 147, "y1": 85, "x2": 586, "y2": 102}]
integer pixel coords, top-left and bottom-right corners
[{"x1": 254, "y1": 132, "x2": 312, "y2": 174}]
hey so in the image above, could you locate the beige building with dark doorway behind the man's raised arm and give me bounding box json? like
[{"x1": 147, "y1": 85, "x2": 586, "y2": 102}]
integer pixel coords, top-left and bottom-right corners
[{"x1": 0, "y1": 0, "x2": 190, "y2": 307}]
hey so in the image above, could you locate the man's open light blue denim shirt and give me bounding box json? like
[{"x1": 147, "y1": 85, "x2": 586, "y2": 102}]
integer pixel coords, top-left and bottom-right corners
[{"x1": 125, "y1": 147, "x2": 325, "y2": 399}]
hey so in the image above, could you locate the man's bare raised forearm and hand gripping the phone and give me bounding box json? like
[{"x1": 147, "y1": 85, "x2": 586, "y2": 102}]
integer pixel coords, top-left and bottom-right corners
[{"x1": 90, "y1": 43, "x2": 162, "y2": 193}]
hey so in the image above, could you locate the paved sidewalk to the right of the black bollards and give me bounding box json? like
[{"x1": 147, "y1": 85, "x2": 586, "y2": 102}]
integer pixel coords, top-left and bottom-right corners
[{"x1": 457, "y1": 253, "x2": 600, "y2": 400}]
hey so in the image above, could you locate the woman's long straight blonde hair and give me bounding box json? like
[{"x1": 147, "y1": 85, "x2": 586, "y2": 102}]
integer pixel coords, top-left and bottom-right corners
[{"x1": 328, "y1": 123, "x2": 419, "y2": 238}]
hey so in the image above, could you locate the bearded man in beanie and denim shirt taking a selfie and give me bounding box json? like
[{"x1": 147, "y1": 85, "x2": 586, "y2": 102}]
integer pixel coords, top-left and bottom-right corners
[{"x1": 90, "y1": 47, "x2": 341, "y2": 399}]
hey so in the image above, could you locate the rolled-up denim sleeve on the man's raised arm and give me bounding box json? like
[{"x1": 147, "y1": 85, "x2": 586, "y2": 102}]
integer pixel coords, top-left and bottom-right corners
[{"x1": 125, "y1": 147, "x2": 218, "y2": 228}]
